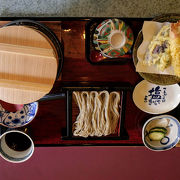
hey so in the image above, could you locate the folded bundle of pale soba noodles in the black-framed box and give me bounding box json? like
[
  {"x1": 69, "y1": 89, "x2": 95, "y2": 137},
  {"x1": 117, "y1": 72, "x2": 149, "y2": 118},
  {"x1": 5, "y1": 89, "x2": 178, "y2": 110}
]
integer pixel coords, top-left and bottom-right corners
[{"x1": 73, "y1": 91, "x2": 120, "y2": 137}]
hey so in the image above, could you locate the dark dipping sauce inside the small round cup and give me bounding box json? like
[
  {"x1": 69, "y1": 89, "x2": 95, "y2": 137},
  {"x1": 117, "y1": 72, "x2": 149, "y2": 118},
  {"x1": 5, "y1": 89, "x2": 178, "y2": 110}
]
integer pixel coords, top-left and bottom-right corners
[{"x1": 5, "y1": 132, "x2": 31, "y2": 151}]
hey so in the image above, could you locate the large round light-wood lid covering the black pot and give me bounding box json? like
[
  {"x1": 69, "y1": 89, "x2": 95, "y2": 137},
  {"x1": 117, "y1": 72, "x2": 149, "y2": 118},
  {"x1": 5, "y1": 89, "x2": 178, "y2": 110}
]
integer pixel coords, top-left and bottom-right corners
[{"x1": 0, "y1": 26, "x2": 58, "y2": 104}]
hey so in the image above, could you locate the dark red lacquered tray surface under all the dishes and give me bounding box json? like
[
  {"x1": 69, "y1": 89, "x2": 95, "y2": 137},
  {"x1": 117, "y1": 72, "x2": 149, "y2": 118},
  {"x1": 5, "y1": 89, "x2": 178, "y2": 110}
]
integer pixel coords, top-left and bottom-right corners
[{"x1": 0, "y1": 17, "x2": 178, "y2": 146}]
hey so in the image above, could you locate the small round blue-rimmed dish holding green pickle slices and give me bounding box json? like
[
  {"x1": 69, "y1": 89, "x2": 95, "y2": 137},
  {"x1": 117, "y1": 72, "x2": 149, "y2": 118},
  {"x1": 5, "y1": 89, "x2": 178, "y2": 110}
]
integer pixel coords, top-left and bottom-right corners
[{"x1": 142, "y1": 115, "x2": 180, "y2": 151}]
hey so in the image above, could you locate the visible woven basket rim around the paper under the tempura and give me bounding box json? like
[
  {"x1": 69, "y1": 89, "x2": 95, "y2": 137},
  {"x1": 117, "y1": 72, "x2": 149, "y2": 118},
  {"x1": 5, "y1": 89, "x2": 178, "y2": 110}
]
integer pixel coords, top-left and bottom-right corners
[{"x1": 133, "y1": 14, "x2": 180, "y2": 85}]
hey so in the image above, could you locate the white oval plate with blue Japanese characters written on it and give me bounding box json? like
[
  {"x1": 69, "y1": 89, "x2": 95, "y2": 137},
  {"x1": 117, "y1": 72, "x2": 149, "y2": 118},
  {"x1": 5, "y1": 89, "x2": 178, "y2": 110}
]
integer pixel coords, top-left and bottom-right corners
[{"x1": 133, "y1": 80, "x2": 180, "y2": 114}]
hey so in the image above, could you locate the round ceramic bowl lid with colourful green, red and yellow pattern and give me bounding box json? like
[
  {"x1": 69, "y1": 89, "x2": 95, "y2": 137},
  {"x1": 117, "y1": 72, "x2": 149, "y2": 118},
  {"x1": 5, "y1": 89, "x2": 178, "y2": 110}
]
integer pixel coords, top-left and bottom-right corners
[{"x1": 93, "y1": 19, "x2": 134, "y2": 58}]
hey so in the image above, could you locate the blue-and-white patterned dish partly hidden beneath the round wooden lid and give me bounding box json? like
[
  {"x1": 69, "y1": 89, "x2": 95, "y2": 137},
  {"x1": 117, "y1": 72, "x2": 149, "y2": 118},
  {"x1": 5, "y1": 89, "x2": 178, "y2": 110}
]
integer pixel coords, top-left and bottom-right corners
[{"x1": 0, "y1": 102, "x2": 38, "y2": 128}]
